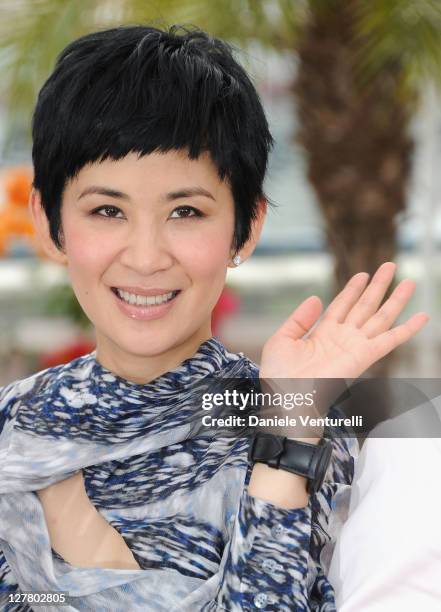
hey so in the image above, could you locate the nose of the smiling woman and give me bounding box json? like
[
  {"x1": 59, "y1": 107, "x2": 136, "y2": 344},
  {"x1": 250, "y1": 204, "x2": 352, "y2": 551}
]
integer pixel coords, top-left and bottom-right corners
[{"x1": 120, "y1": 221, "x2": 174, "y2": 277}]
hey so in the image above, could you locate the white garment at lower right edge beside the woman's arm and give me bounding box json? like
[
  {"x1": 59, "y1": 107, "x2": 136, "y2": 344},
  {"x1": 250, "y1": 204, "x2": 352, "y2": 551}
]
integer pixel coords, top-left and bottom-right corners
[{"x1": 329, "y1": 400, "x2": 441, "y2": 612}]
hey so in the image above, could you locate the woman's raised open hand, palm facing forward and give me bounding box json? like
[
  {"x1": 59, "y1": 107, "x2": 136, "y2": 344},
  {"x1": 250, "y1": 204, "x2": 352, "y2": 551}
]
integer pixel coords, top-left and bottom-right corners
[{"x1": 260, "y1": 262, "x2": 429, "y2": 379}]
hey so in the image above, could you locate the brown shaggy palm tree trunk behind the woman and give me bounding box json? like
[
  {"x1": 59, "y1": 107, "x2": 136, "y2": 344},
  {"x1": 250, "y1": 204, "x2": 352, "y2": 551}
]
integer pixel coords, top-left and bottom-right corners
[{"x1": 294, "y1": 0, "x2": 413, "y2": 288}]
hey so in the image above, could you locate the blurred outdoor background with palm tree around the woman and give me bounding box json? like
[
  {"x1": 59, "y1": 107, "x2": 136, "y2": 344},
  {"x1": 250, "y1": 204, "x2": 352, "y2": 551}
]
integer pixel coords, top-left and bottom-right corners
[{"x1": 0, "y1": 0, "x2": 441, "y2": 385}]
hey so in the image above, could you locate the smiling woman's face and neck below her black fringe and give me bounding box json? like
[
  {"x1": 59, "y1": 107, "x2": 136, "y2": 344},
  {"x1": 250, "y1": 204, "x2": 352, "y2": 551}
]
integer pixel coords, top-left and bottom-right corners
[{"x1": 39, "y1": 151, "x2": 248, "y2": 382}]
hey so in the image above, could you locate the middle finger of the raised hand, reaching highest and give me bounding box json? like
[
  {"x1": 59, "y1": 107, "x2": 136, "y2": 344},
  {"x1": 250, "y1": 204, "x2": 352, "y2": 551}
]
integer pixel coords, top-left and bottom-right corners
[{"x1": 345, "y1": 261, "x2": 396, "y2": 327}]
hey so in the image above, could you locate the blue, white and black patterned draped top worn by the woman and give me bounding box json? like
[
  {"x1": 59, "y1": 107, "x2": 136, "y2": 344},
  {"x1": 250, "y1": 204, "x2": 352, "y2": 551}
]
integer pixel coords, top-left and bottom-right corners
[{"x1": 0, "y1": 338, "x2": 352, "y2": 612}]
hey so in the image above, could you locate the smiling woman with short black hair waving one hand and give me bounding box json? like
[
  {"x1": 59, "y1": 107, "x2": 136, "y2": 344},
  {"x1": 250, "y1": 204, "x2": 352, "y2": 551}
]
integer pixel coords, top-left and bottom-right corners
[{"x1": 0, "y1": 26, "x2": 427, "y2": 611}]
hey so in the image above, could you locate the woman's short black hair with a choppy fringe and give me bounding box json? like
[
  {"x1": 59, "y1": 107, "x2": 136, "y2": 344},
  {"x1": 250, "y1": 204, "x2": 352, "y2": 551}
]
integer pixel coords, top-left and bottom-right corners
[{"x1": 32, "y1": 25, "x2": 273, "y2": 251}]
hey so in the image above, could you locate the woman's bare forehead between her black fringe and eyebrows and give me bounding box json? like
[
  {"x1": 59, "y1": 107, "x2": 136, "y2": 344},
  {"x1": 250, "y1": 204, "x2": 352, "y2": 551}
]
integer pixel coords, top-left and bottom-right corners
[{"x1": 66, "y1": 151, "x2": 231, "y2": 196}]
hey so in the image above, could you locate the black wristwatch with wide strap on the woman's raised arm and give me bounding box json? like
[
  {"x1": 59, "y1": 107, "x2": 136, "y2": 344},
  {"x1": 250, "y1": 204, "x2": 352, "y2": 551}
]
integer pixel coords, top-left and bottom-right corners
[{"x1": 248, "y1": 432, "x2": 332, "y2": 493}]
